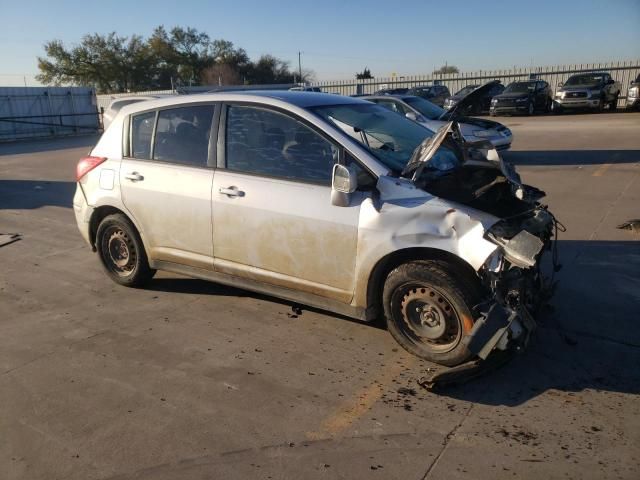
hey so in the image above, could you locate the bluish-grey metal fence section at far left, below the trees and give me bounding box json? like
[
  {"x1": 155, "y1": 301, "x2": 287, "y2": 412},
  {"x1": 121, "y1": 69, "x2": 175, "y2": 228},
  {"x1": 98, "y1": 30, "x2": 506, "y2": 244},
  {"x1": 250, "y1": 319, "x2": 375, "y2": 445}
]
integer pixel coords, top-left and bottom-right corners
[{"x1": 0, "y1": 87, "x2": 100, "y2": 141}]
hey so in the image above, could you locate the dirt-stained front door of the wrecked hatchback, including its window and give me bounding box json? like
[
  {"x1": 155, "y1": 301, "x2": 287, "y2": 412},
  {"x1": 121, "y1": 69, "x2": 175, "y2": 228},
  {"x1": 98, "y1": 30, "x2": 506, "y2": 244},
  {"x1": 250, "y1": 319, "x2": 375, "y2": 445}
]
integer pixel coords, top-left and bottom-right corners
[{"x1": 213, "y1": 104, "x2": 364, "y2": 302}]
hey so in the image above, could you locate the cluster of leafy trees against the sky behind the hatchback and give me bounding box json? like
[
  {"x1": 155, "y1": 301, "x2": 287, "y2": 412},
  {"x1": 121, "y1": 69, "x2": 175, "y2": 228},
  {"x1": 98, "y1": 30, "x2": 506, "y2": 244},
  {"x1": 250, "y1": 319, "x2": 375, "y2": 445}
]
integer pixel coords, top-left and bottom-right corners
[{"x1": 37, "y1": 25, "x2": 298, "y2": 93}]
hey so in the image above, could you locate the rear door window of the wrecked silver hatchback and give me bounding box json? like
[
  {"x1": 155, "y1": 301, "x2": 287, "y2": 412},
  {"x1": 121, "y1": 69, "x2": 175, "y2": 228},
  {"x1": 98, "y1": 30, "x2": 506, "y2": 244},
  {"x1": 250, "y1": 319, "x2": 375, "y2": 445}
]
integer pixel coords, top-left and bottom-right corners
[{"x1": 153, "y1": 105, "x2": 214, "y2": 167}]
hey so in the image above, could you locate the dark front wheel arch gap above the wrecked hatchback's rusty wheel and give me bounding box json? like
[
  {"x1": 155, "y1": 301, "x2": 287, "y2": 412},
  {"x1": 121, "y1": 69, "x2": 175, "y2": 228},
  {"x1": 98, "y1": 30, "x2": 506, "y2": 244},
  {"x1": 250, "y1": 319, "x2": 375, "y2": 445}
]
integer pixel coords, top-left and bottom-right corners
[{"x1": 366, "y1": 247, "x2": 479, "y2": 320}]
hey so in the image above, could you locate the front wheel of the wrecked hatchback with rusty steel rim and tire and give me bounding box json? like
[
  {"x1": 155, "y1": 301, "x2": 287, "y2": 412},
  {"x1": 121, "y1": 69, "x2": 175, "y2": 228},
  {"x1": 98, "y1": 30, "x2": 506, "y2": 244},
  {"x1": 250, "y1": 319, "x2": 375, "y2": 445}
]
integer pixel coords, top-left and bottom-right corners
[{"x1": 382, "y1": 261, "x2": 482, "y2": 366}]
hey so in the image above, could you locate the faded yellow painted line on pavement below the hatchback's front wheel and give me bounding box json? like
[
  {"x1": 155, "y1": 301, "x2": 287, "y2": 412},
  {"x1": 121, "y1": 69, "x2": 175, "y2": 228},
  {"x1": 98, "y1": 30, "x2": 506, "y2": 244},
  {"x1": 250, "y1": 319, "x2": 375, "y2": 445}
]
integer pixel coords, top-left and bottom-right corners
[{"x1": 307, "y1": 356, "x2": 415, "y2": 440}]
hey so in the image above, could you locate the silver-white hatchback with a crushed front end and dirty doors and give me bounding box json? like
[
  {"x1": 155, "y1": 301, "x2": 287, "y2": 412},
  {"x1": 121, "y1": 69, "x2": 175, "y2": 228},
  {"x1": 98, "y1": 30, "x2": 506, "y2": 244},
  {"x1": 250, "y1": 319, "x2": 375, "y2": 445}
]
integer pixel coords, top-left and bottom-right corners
[{"x1": 73, "y1": 91, "x2": 554, "y2": 365}]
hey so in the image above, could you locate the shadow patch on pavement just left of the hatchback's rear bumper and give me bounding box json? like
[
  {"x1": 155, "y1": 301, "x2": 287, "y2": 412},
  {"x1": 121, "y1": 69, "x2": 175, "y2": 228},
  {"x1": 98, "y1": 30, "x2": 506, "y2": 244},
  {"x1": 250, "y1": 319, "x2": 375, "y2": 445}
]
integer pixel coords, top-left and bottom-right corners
[{"x1": 0, "y1": 180, "x2": 76, "y2": 210}]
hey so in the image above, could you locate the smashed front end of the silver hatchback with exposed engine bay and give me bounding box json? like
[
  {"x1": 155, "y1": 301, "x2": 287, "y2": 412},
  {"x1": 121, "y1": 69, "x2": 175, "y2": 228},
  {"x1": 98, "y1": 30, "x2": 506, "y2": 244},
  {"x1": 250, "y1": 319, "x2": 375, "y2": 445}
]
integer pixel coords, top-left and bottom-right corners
[{"x1": 403, "y1": 121, "x2": 564, "y2": 382}]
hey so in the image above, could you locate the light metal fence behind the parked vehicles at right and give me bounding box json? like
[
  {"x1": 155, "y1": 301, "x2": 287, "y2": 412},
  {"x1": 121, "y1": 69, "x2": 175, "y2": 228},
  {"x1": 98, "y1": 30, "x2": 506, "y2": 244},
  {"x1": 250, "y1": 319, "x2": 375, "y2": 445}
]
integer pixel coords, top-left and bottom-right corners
[{"x1": 313, "y1": 60, "x2": 640, "y2": 106}]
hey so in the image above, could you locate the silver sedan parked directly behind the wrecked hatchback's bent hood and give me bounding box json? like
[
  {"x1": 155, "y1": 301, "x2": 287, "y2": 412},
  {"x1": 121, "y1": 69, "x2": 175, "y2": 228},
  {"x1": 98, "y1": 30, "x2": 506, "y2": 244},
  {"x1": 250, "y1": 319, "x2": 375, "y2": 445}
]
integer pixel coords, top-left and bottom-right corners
[{"x1": 361, "y1": 83, "x2": 513, "y2": 150}]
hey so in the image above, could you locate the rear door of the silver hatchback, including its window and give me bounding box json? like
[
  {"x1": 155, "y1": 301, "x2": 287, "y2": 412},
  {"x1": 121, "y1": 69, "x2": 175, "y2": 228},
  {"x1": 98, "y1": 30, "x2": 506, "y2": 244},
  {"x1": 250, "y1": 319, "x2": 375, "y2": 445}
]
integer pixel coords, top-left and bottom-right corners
[{"x1": 120, "y1": 104, "x2": 215, "y2": 269}]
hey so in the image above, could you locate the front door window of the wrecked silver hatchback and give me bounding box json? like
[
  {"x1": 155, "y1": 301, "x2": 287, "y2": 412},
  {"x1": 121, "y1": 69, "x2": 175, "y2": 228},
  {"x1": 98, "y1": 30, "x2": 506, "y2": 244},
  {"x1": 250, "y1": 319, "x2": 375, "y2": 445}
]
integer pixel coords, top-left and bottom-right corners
[{"x1": 225, "y1": 106, "x2": 338, "y2": 185}]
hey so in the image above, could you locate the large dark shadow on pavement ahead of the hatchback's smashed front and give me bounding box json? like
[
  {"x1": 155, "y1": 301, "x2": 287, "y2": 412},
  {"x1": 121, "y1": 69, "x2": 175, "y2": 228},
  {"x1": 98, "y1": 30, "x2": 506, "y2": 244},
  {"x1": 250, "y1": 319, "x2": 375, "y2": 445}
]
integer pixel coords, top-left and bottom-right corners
[{"x1": 440, "y1": 240, "x2": 640, "y2": 406}]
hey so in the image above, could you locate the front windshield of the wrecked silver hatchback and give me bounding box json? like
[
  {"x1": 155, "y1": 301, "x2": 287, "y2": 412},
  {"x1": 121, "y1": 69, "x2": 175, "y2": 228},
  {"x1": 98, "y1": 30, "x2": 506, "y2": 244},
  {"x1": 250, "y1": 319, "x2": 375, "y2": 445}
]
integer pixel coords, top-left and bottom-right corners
[{"x1": 310, "y1": 102, "x2": 456, "y2": 173}]
